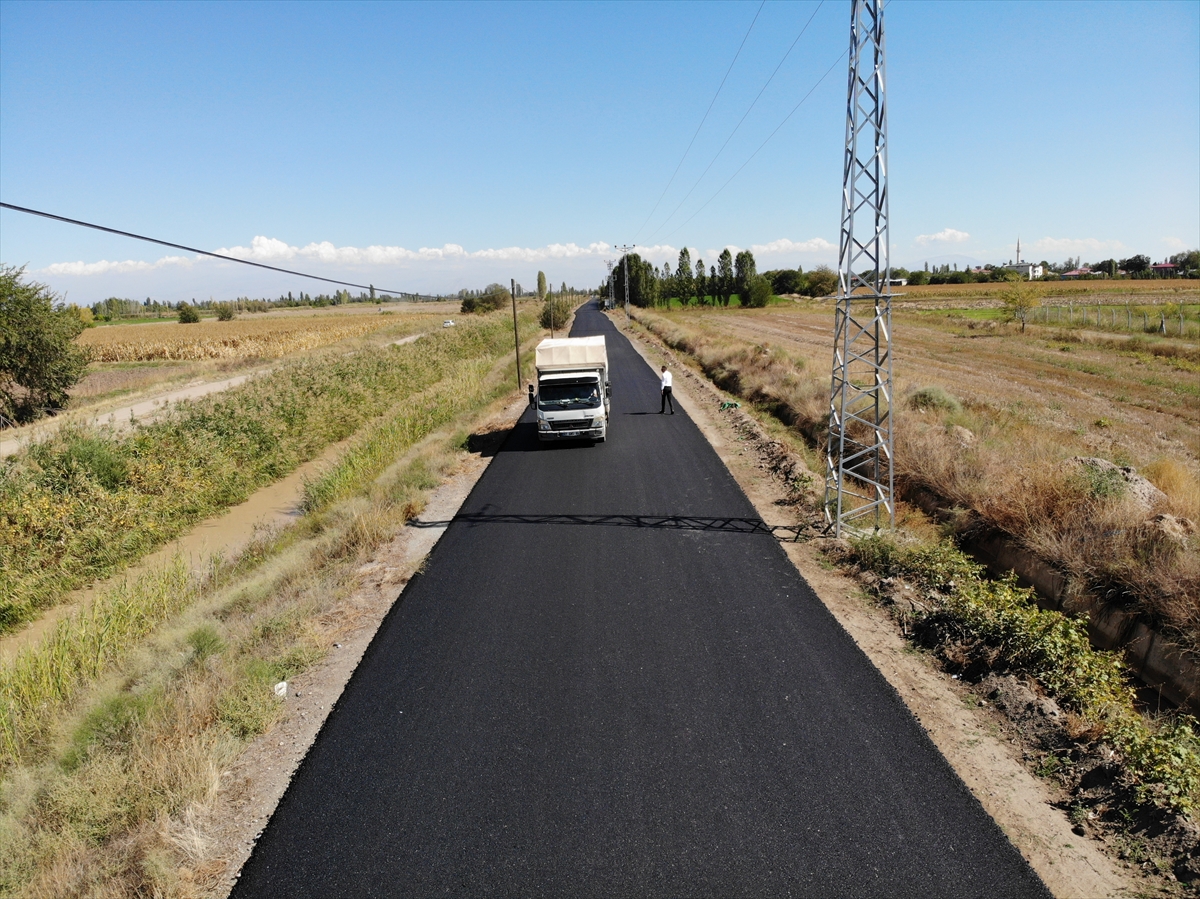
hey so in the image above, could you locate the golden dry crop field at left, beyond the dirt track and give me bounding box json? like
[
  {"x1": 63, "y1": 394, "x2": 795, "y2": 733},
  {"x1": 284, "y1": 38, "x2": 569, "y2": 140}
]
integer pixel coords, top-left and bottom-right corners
[{"x1": 77, "y1": 314, "x2": 427, "y2": 362}]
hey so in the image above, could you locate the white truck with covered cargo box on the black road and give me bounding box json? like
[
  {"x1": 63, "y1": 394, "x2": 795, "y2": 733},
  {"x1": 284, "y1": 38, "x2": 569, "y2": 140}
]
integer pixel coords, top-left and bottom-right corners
[{"x1": 529, "y1": 336, "x2": 612, "y2": 443}]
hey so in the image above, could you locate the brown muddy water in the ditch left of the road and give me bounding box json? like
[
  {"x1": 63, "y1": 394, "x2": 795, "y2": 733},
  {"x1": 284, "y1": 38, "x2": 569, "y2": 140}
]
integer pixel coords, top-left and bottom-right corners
[{"x1": 0, "y1": 438, "x2": 353, "y2": 661}]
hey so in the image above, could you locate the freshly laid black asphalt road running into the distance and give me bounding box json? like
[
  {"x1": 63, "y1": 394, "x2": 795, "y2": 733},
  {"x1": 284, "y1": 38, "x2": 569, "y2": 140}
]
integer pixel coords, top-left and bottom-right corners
[{"x1": 234, "y1": 308, "x2": 1049, "y2": 897}]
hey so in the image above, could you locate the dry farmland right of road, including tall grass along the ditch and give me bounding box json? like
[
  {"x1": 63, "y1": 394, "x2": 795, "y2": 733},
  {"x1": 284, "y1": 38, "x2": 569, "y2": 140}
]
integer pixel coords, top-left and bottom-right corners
[{"x1": 637, "y1": 294, "x2": 1200, "y2": 646}]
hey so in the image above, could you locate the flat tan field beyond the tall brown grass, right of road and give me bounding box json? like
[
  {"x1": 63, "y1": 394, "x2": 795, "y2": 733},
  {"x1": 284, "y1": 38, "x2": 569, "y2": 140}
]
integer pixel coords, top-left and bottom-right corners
[{"x1": 672, "y1": 304, "x2": 1200, "y2": 458}]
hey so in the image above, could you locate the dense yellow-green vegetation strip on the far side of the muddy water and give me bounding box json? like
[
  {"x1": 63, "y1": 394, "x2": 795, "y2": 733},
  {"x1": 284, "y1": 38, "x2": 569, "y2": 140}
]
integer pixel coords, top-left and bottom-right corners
[{"x1": 0, "y1": 316, "x2": 523, "y2": 633}]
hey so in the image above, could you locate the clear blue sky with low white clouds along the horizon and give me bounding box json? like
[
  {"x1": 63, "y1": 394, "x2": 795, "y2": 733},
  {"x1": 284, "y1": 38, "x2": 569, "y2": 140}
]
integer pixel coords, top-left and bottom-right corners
[{"x1": 0, "y1": 0, "x2": 1200, "y2": 302}]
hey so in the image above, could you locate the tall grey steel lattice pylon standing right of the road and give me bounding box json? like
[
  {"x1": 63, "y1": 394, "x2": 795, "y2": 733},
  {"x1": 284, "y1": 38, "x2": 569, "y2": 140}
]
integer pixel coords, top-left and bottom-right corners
[{"x1": 824, "y1": 0, "x2": 895, "y2": 537}]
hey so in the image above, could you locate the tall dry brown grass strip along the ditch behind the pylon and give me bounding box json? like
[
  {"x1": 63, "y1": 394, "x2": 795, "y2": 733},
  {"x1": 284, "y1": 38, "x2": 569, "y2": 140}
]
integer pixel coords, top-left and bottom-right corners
[{"x1": 634, "y1": 304, "x2": 1200, "y2": 647}]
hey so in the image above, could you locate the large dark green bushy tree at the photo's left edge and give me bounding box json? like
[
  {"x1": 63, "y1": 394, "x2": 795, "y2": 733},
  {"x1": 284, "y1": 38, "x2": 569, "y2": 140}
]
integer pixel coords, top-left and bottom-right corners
[{"x1": 0, "y1": 265, "x2": 88, "y2": 421}]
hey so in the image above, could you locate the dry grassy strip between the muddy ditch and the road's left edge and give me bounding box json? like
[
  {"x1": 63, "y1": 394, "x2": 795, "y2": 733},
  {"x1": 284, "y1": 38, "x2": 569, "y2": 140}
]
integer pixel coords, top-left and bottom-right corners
[{"x1": 0, "y1": 313, "x2": 535, "y2": 895}]
